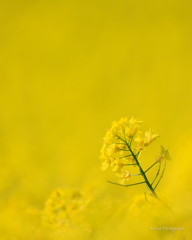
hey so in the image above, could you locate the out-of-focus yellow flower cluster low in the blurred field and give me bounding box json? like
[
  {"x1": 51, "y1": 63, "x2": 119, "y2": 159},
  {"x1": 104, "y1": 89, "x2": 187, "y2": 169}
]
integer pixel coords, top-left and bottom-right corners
[{"x1": 42, "y1": 189, "x2": 88, "y2": 231}]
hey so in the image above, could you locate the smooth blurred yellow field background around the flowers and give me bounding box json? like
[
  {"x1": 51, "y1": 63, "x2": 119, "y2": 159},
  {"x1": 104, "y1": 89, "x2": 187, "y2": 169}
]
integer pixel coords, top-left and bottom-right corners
[{"x1": 0, "y1": 0, "x2": 192, "y2": 240}]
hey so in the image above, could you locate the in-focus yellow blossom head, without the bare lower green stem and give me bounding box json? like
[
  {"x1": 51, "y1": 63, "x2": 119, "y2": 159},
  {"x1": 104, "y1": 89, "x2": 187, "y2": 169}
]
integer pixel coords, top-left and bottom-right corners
[{"x1": 100, "y1": 117, "x2": 159, "y2": 184}]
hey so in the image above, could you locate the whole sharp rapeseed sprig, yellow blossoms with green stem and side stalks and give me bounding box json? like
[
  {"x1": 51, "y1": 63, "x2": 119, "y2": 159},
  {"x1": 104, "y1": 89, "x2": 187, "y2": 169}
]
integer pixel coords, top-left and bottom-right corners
[{"x1": 100, "y1": 117, "x2": 171, "y2": 211}]
